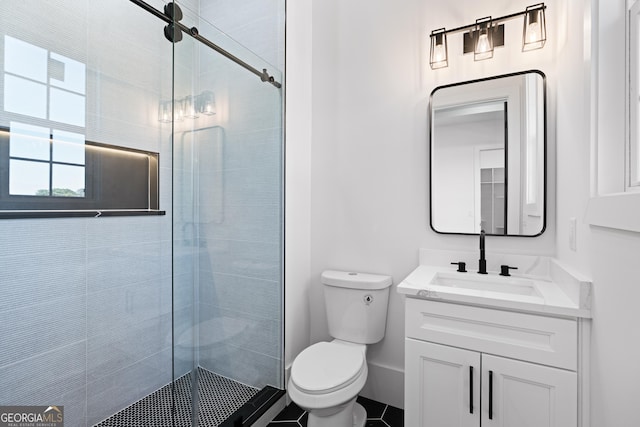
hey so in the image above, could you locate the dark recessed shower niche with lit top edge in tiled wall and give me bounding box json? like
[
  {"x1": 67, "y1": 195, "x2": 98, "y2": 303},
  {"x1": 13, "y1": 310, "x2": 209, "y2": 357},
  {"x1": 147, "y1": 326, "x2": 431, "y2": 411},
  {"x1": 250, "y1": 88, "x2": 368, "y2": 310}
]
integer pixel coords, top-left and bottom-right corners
[{"x1": 0, "y1": 127, "x2": 159, "y2": 217}]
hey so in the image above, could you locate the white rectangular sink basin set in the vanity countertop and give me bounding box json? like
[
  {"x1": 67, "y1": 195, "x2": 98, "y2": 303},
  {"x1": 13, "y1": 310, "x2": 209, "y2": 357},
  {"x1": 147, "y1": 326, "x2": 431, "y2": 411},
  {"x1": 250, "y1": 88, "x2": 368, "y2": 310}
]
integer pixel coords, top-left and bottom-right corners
[{"x1": 430, "y1": 272, "x2": 542, "y2": 298}]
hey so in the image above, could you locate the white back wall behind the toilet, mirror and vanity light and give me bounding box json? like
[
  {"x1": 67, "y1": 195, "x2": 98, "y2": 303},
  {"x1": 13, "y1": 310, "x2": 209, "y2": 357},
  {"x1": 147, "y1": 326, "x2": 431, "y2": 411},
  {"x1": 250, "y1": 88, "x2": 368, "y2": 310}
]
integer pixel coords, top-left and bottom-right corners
[{"x1": 296, "y1": 0, "x2": 568, "y2": 406}]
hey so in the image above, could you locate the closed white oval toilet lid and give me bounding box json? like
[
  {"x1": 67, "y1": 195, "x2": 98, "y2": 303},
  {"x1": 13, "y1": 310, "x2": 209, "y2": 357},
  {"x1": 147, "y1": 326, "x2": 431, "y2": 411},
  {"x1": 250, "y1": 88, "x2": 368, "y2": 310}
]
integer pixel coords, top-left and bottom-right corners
[{"x1": 291, "y1": 342, "x2": 365, "y2": 394}]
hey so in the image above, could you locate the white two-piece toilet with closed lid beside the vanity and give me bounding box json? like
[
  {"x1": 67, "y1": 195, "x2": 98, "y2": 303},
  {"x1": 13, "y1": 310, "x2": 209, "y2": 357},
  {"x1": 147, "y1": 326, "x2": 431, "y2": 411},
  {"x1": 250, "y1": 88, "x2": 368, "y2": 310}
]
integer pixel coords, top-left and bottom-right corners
[{"x1": 288, "y1": 270, "x2": 392, "y2": 427}]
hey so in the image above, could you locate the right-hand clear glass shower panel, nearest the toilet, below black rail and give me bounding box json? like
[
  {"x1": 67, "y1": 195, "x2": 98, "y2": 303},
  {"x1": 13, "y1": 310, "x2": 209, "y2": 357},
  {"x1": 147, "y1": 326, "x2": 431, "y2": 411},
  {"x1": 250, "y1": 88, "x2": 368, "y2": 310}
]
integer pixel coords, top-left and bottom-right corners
[{"x1": 170, "y1": 4, "x2": 284, "y2": 425}]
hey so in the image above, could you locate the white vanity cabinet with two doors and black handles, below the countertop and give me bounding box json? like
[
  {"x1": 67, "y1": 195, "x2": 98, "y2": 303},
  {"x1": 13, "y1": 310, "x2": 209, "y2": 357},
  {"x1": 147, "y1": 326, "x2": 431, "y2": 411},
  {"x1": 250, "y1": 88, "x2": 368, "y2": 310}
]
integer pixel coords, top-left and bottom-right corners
[{"x1": 405, "y1": 298, "x2": 578, "y2": 427}]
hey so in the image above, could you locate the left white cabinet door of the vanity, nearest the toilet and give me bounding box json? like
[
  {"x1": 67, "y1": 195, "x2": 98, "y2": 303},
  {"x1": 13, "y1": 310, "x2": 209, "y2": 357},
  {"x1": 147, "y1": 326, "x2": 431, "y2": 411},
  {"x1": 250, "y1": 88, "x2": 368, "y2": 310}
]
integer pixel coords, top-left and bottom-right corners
[{"x1": 404, "y1": 338, "x2": 480, "y2": 427}]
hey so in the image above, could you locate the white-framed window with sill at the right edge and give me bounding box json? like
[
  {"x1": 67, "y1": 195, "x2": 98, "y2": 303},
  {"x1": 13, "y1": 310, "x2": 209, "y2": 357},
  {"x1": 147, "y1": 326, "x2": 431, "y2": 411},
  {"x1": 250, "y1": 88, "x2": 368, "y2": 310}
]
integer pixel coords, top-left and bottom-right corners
[{"x1": 586, "y1": 1, "x2": 640, "y2": 233}]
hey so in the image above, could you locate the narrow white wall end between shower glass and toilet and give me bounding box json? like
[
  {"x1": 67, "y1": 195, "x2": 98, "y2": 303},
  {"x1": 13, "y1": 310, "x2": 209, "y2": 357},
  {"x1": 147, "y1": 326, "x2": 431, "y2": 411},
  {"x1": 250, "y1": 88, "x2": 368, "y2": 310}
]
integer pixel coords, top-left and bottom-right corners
[{"x1": 285, "y1": 0, "x2": 313, "y2": 372}]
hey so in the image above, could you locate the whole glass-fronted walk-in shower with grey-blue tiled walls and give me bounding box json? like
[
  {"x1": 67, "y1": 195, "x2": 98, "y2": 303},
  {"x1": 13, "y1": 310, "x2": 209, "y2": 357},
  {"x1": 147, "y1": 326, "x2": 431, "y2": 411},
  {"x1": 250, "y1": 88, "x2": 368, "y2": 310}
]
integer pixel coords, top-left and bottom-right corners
[{"x1": 0, "y1": 0, "x2": 284, "y2": 427}]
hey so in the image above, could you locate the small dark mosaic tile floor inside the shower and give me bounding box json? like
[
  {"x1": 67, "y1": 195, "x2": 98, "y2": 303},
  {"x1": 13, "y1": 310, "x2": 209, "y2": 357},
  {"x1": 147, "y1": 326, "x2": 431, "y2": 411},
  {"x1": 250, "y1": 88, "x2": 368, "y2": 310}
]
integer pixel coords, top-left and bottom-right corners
[{"x1": 95, "y1": 368, "x2": 259, "y2": 427}]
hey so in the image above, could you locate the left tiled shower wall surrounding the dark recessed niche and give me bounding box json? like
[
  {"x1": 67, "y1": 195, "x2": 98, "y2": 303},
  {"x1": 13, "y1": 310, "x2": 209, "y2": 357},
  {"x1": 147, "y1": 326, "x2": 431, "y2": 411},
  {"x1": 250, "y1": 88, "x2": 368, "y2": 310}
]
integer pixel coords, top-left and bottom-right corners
[{"x1": 0, "y1": 0, "x2": 171, "y2": 427}]
